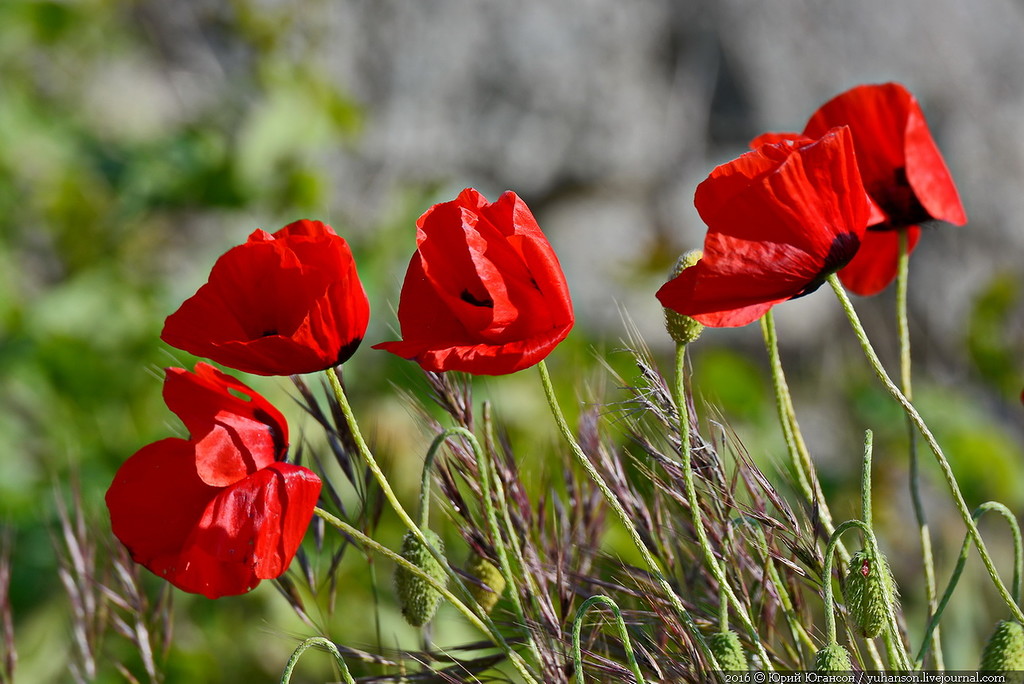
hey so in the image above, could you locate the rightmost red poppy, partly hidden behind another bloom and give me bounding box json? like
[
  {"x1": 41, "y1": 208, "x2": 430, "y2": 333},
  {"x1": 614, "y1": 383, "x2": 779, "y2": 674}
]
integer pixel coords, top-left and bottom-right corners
[{"x1": 804, "y1": 83, "x2": 967, "y2": 295}]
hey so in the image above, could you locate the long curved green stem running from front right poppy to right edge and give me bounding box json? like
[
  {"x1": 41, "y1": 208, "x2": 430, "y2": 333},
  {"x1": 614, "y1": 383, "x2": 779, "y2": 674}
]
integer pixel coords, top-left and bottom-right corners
[{"x1": 828, "y1": 273, "x2": 1024, "y2": 623}]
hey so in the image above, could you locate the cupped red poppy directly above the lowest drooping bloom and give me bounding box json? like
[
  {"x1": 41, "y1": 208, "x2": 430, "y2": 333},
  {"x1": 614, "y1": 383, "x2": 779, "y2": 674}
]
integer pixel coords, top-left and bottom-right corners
[{"x1": 161, "y1": 220, "x2": 370, "y2": 375}]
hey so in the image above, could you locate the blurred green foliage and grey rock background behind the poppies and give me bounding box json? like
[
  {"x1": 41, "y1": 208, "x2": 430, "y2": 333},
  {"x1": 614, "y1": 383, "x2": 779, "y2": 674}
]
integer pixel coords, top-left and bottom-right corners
[{"x1": 6, "y1": 0, "x2": 1024, "y2": 682}]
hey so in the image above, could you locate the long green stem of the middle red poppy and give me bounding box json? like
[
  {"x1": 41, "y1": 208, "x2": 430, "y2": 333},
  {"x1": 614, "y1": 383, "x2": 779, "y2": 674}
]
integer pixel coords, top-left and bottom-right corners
[{"x1": 537, "y1": 360, "x2": 729, "y2": 671}]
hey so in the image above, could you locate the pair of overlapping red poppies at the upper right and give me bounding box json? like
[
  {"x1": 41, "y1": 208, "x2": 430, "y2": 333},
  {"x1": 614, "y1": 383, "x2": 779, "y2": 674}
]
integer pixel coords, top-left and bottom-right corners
[{"x1": 657, "y1": 83, "x2": 967, "y2": 327}]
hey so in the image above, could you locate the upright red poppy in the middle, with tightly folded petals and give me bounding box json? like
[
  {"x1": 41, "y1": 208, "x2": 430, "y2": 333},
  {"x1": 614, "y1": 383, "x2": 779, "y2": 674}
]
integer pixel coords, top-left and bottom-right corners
[{"x1": 374, "y1": 188, "x2": 573, "y2": 375}]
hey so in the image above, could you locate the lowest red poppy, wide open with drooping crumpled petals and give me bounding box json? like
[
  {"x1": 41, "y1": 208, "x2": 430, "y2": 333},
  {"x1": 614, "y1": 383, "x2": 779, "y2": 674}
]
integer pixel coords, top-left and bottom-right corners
[{"x1": 106, "y1": 364, "x2": 321, "y2": 598}]
